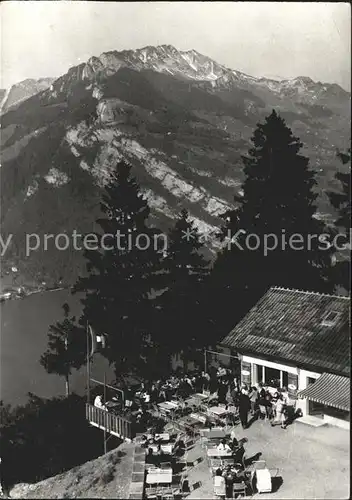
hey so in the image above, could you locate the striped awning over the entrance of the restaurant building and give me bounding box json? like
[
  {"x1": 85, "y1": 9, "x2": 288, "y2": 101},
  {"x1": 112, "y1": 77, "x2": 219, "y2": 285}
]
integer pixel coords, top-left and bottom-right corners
[{"x1": 298, "y1": 373, "x2": 350, "y2": 411}]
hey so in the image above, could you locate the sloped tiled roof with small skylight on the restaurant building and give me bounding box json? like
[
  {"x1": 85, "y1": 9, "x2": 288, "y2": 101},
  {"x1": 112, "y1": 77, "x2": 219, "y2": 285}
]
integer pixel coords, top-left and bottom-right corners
[{"x1": 221, "y1": 287, "x2": 350, "y2": 376}]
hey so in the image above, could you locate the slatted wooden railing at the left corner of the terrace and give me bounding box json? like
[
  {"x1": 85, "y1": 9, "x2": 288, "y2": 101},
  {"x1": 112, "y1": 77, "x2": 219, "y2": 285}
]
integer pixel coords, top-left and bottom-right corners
[{"x1": 86, "y1": 403, "x2": 134, "y2": 440}]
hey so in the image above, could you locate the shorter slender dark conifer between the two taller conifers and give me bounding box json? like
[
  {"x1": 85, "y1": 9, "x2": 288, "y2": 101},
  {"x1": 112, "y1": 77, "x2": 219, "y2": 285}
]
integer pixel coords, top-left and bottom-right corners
[{"x1": 158, "y1": 210, "x2": 209, "y2": 370}]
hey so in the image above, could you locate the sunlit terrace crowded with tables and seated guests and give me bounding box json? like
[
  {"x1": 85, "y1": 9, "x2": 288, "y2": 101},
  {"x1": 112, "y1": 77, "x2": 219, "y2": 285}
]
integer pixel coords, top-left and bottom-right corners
[{"x1": 87, "y1": 369, "x2": 349, "y2": 499}]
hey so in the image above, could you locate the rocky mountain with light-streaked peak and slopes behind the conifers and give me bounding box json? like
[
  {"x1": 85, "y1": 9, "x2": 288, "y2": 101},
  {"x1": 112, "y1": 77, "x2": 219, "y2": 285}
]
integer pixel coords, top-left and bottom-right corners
[{"x1": 1, "y1": 45, "x2": 351, "y2": 288}]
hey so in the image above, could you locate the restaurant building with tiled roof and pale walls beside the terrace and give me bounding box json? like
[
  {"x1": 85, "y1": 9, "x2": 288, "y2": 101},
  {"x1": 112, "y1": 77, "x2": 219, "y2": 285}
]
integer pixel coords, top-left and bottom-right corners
[{"x1": 220, "y1": 287, "x2": 350, "y2": 429}]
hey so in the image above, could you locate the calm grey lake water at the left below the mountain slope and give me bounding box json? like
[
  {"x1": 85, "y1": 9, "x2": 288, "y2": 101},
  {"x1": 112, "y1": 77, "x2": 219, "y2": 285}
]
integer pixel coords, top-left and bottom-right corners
[{"x1": 0, "y1": 290, "x2": 111, "y2": 405}]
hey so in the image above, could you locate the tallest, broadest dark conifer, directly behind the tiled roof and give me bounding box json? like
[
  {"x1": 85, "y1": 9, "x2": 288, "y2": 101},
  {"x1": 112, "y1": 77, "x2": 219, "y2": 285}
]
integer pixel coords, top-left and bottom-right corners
[{"x1": 211, "y1": 111, "x2": 333, "y2": 334}]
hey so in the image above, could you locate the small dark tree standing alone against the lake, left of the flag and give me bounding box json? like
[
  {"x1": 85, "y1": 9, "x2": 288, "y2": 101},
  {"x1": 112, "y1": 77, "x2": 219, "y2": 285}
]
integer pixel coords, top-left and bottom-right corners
[{"x1": 40, "y1": 303, "x2": 86, "y2": 396}]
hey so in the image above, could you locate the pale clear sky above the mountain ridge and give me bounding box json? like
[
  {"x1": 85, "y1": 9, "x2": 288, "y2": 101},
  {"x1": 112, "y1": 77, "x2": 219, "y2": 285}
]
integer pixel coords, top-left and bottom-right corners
[{"x1": 0, "y1": 0, "x2": 351, "y2": 90}]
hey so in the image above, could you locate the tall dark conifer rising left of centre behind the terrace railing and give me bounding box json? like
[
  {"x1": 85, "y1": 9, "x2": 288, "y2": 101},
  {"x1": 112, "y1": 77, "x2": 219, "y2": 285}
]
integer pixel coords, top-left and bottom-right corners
[{"x1": 75, "y1": 161, "x2": 165, "y2": 376}]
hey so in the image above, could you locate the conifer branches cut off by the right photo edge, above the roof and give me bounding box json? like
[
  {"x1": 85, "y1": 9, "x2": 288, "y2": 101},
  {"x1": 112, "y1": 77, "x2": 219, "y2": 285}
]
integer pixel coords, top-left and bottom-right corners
[{"x1": 328, "y1": 149, "x2": 351, "y2": 291}]
